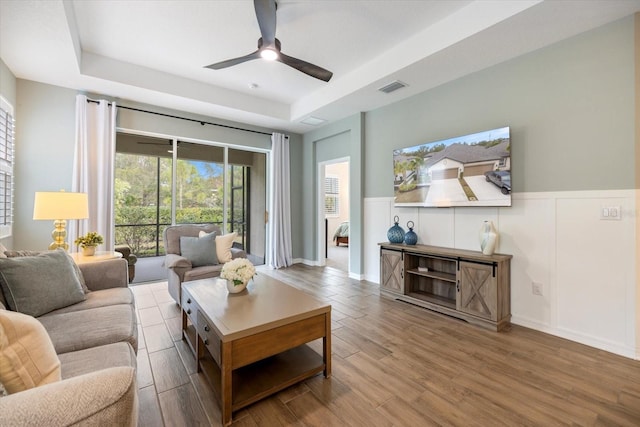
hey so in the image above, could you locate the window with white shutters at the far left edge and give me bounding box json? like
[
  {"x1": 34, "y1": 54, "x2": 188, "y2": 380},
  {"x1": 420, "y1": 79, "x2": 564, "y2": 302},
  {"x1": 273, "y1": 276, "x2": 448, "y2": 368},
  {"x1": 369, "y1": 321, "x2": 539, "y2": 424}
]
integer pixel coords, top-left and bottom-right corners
[{"x1": 0, "y1": 96, "x2": 15, "y2": 238}]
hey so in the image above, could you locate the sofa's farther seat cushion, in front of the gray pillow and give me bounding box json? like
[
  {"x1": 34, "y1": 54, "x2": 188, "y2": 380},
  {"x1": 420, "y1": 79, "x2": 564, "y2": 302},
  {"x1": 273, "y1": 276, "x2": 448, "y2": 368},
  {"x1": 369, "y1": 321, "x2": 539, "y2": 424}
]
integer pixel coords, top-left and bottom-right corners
[{"x1": 38, "y1": 304, "x2": 138, "y2": 354}]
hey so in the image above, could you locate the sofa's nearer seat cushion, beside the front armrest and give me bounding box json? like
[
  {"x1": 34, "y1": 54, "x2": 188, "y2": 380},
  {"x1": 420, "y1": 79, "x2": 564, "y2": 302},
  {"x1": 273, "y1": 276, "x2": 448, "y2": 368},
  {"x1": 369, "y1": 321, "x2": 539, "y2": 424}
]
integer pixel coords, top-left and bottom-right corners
[{"x1": 58, "y1": 342, "x2": 137, "y2": 380}]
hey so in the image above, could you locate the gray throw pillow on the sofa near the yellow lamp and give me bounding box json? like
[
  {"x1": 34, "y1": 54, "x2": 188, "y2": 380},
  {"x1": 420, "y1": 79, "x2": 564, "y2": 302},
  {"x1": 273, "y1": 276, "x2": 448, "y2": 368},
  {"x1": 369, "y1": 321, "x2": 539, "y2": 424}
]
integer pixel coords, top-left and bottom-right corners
[{"x1": 0, "y1": 250, "x2": 86, "y2": 317}]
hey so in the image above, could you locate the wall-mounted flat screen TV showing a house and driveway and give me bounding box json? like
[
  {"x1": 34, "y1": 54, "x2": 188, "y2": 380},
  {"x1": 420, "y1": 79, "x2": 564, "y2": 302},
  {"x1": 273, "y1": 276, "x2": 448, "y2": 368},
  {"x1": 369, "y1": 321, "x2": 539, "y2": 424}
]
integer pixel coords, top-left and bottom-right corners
[{"x1": 393, "y1": 127, "x2": 511, "y2": 207}]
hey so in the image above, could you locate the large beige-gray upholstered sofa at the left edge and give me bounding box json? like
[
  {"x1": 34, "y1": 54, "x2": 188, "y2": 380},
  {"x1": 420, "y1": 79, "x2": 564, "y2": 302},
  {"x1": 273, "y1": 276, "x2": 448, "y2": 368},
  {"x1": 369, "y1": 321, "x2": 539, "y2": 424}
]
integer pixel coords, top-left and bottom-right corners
[{"x1": 0, "y1": 259, "x2": 138, "y2": 426}]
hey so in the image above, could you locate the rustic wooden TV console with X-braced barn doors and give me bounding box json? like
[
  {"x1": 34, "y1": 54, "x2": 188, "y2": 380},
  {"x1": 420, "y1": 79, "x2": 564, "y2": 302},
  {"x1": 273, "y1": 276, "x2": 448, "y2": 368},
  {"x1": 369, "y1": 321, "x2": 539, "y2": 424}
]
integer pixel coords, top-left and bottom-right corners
[{"x1": 380, "y1": 243, "x2": 512, "y2": 331}]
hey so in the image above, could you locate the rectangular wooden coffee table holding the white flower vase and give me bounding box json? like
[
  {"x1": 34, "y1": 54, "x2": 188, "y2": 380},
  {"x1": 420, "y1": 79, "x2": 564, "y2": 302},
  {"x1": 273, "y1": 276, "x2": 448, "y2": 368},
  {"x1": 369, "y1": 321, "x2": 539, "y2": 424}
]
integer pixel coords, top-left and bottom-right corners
[{"x1": 182, "y1": 274, "x2": 331, "y2": 425}]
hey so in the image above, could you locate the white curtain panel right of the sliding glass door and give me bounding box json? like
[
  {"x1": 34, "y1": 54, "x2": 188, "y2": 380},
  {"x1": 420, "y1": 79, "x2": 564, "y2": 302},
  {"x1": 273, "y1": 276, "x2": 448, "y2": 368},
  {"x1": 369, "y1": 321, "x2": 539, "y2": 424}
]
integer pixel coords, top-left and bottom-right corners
[{"x1": 268, "y1": 133, "x2": 293, "y2": 268}]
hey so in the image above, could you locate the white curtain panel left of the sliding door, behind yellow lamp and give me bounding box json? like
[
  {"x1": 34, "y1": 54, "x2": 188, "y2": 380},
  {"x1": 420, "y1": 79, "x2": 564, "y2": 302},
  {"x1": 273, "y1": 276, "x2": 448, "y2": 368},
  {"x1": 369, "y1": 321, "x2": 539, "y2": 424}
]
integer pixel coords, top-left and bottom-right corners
[{"x1": 68, "y1": 95, "x2": 116, "y2": 251}]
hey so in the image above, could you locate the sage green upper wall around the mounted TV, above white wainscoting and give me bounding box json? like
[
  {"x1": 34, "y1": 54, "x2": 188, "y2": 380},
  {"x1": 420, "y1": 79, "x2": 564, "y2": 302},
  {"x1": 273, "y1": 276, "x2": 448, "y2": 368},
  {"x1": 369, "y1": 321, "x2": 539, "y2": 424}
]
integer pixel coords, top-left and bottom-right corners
[{"x1": 364, "y1": 17, "x2": 635, "y2": 197}]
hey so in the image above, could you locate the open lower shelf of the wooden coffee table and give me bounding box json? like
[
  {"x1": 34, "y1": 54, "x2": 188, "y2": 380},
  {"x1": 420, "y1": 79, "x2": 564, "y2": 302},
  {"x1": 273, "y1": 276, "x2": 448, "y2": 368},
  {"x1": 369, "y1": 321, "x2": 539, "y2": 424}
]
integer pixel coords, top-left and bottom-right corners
[{"x1": 199, "y1": 344, "x2": 325, "y2": 411}]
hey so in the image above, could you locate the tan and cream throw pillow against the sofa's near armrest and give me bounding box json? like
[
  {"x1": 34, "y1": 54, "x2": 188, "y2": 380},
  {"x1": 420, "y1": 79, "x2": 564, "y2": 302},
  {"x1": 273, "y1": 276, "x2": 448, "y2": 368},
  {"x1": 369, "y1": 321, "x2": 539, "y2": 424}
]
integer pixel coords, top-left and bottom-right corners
[{"x1": 0, "y1": 310, "x2": 61, "y2": 393}]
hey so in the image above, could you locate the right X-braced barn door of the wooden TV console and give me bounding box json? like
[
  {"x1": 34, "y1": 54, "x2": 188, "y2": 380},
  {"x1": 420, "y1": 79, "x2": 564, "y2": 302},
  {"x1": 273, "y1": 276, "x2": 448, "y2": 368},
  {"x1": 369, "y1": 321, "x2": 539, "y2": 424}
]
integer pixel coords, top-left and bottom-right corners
[{"x1": 456, "y1": 261, "x2": 498, "y2": 320}]
